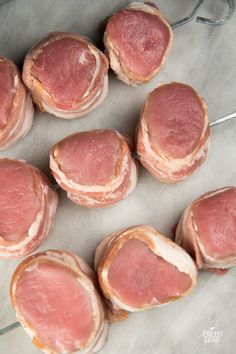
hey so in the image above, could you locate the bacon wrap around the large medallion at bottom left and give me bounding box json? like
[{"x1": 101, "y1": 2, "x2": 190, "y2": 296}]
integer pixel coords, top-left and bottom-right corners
[{"x1": 12, "y1": 250, "x2": 108, "y2": 354}]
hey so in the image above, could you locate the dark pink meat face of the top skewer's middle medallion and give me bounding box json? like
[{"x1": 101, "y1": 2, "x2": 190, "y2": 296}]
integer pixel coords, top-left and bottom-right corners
[{"x1": 31, "y1": 38, "x2": 96, "y2": 109}]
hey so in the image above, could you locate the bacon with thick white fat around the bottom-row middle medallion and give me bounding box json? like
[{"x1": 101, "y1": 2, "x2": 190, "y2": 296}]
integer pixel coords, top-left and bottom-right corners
[{"x1": 94, "y1": 225, "x2": 197, "y2": 312}]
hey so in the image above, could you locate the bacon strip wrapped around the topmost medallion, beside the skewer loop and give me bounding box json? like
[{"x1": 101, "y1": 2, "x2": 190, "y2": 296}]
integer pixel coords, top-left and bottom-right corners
[{"x1": 104, "y1": 2, "x2": 172, "y2": 86}]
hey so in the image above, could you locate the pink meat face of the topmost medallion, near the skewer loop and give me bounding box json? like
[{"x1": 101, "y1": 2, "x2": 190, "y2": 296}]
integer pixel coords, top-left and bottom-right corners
[{"x1": 106, "y1": 9, "x2": 170, "y2": 77}]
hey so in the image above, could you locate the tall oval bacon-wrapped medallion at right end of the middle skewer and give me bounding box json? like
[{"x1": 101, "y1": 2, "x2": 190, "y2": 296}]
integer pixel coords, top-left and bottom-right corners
[{"x1": 136, "y1": 82, "x2": 210, "y2": 183}]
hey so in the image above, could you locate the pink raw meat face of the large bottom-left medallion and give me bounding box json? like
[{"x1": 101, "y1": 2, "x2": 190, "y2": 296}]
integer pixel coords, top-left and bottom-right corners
[{"x1": 15, "y1": 262, "x2": 94, "y2": 352}]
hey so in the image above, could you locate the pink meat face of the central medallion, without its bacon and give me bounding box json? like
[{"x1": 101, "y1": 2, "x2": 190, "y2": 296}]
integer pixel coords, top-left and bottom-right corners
[{"x1": 57, "y1": 130, "x2": 120, "y2": 185}]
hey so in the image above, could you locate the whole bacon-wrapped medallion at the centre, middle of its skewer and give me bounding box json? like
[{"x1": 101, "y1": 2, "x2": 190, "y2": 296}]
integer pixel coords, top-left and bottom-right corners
[{"x1": 50, "y1": 129, "x2": 138, "y2": 208}]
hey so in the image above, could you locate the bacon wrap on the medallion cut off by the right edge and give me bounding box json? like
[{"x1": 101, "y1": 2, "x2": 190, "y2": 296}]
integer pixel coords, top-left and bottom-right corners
[{"x1": 176, "y1": 187, "x2": 236, "y2": 269}]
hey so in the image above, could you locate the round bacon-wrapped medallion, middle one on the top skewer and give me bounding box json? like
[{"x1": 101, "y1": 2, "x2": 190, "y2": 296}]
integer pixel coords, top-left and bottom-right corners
[{"x1": 23, "y1": 32, "x2": 108, "y2": 119}]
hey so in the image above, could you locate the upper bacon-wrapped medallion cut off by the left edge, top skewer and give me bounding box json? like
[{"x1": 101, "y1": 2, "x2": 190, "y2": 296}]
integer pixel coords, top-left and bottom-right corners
[{"x1": 0, "y1": 56, "x2": 34, "y2": 150}]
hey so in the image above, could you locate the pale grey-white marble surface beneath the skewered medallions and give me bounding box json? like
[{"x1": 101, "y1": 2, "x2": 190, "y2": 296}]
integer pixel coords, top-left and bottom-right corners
[{"x1": 0, "y1": 0, "x2": 236, "y2": 354}]
